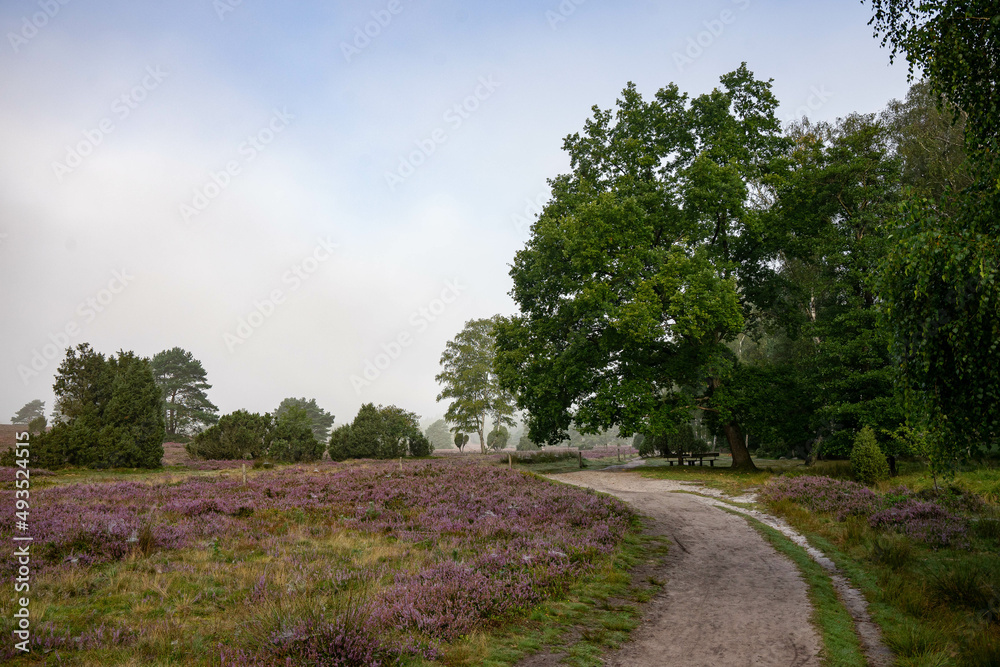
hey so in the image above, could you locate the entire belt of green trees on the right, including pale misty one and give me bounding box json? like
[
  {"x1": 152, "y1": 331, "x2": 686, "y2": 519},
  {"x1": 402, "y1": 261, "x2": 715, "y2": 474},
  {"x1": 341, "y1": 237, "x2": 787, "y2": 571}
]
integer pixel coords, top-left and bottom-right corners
[{"x1": 437, "y1": 0, "x2": 1000, "y2": 468}]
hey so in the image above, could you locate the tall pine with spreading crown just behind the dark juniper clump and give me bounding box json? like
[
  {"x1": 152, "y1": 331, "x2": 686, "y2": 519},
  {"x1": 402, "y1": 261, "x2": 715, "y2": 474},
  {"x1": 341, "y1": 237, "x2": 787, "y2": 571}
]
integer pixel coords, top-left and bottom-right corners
[{"x1": 152, "y1": 347, "x2": 219, "y2": 436}]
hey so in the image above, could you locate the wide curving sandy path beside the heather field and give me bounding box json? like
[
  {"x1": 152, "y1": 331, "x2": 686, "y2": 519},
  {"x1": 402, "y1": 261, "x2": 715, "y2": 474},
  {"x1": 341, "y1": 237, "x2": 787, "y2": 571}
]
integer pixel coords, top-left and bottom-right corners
[{"x1": 552, "y1": 472, "x2": 821, "y2": 667}]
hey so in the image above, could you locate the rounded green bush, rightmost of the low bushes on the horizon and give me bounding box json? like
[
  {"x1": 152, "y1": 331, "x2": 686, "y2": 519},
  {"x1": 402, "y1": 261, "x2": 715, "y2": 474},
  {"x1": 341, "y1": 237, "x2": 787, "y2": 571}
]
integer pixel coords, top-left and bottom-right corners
[{"x1": 329, "y1": 403, "x2": 424, "y2": 461}]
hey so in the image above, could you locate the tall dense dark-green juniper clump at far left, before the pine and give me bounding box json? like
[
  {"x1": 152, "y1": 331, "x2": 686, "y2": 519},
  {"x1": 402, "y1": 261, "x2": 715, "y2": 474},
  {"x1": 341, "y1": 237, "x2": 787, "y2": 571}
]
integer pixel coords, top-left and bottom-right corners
[{"x1": 14, "y1": 350, "x2": 164, "y2": 468}]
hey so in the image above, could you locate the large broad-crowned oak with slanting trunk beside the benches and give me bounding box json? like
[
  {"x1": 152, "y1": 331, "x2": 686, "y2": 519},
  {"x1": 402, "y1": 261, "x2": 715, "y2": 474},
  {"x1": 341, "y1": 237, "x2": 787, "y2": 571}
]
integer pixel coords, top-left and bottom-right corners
[{"x1": 497, "y1": 65, "x2": 789, "y2": 467}]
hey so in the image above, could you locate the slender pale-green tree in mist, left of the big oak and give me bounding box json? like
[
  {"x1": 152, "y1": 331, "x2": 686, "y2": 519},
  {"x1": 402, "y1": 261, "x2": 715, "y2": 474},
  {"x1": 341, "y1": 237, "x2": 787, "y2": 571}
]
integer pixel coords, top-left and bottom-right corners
[{"x1": 435, "y1": 317, "x2": 515, "y2": 453}]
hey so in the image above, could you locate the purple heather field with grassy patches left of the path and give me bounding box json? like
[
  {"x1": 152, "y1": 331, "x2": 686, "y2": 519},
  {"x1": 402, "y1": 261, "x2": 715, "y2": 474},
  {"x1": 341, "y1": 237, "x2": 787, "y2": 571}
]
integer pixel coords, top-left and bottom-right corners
[{"x1": 0, "y1": 456, "x2": 638, "y2": 665}]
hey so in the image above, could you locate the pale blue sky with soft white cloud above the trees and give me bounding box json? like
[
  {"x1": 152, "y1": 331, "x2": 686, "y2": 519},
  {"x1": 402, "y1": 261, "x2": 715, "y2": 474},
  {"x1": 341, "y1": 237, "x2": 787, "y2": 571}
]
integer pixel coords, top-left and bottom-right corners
[{"x1": 0, "y1": 0, "x2": 908, "y2": 424}]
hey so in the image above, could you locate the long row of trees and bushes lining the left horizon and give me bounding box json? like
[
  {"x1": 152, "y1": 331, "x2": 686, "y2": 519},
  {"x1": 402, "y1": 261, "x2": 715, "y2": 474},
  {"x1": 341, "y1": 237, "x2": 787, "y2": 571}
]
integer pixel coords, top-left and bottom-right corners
[{"x1": 7, "y1": 343, "x2": 433, "y2": 469}]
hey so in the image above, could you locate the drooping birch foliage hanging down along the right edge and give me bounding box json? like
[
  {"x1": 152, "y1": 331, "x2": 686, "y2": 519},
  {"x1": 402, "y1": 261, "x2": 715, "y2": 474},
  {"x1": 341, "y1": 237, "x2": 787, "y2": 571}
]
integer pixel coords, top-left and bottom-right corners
[{"x1": 872, "y1": 0, "x2": 1000, "y2": 468}]
